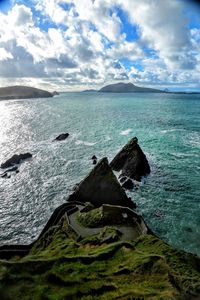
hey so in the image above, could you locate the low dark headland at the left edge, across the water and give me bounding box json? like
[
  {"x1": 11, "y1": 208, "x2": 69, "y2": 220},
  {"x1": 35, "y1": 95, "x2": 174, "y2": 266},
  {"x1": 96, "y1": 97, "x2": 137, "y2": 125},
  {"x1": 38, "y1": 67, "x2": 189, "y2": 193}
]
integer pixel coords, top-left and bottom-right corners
[{"x1": 0, "y1": 85, "x2": 58, "y2": 100}]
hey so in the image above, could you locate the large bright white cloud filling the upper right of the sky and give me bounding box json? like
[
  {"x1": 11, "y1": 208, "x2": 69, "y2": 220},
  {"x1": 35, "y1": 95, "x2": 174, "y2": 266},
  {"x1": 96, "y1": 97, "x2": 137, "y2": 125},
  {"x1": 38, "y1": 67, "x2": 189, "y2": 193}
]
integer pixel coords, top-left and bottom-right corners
[{"x1": 119, "y1": 0, "x2": 195, "y2": 70}]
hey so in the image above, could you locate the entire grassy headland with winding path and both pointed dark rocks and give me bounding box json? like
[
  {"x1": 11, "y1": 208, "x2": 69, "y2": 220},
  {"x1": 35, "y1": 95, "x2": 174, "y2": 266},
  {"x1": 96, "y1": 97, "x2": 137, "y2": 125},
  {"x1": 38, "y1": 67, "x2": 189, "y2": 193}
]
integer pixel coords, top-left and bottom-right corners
[{"x1": 0, "y1": 138, "x2": 200, "y2": 299}]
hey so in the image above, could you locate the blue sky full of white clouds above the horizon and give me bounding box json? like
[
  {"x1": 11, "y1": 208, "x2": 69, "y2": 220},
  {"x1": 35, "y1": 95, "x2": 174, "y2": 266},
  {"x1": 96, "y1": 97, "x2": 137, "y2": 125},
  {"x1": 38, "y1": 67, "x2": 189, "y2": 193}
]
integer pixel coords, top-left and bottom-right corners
[{"x1": 0, "y1": 0, "x2": 200, "y2": 91}]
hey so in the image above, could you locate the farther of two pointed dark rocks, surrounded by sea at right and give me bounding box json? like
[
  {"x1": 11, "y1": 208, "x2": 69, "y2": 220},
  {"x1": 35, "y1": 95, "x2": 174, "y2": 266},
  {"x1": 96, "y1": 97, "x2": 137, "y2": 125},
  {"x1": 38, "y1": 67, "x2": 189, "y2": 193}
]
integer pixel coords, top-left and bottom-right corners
[{"x1": 110, "y1": 137, "x2": 150, "y2": 181}]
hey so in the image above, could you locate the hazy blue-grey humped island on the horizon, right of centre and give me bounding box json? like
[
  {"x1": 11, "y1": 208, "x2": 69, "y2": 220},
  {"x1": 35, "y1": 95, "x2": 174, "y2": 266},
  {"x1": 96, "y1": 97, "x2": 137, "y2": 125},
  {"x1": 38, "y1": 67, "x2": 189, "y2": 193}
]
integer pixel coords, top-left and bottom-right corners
[{"x1": 99, "y1": 82, "x2": 164, "y2": 93}]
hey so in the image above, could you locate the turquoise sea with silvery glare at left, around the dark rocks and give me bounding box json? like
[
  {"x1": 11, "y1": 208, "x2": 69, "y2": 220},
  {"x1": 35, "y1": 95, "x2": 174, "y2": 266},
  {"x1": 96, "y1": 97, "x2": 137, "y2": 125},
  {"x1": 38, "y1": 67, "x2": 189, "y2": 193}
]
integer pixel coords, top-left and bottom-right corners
[{"x1": 0, "y1": 93, "x2": 200, "y2": 254}]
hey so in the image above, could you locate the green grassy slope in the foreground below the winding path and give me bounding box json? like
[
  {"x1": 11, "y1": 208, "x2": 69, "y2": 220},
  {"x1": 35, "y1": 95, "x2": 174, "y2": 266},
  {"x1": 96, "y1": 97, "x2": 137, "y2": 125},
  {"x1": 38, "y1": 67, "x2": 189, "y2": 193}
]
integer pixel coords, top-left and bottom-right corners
[{"x1": 0, "y1": 220, "x2": 200, "y2": 300}]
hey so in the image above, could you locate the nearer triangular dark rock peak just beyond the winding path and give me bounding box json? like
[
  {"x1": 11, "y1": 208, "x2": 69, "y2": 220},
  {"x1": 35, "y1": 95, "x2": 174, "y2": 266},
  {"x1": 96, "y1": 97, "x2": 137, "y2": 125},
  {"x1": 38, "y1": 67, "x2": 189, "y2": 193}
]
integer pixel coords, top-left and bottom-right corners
[{"x1": 68, "y1": 157, "x2": 134, "y2": 208}]
